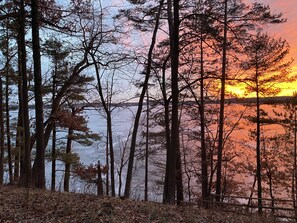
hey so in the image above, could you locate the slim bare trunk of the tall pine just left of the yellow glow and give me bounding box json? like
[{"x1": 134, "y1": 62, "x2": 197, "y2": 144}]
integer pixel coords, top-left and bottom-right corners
[{"x1": 216, "y1": 0, "x2": 228, "y2": 202}]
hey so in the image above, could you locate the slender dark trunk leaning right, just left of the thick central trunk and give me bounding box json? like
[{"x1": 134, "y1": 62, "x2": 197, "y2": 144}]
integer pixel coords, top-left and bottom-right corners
[{"x1": 124, "y1": 0, "x2": 164, "y2": 198}]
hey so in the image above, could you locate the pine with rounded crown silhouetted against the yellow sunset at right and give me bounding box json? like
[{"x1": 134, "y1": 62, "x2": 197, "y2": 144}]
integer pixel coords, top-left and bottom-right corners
[{"x1": 242, "y1": 32, "x2": 292, "y2": 214}]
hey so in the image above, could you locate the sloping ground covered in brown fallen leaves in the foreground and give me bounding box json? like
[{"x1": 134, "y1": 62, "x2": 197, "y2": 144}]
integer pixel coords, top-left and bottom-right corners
[{"x1": 0, "y1": 186, "x2": 276, "y2": 223}]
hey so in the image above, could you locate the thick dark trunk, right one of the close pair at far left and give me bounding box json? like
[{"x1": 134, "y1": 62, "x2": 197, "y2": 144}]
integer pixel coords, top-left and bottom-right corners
[{"x1": 31, "y1": 0, "x2": 45, "y2": 188}]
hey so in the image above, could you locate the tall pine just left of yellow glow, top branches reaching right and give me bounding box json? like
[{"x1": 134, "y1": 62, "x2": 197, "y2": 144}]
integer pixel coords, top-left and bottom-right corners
[{"x1": 198, "y1": 0, "x2": 284, "y2": 201}]
